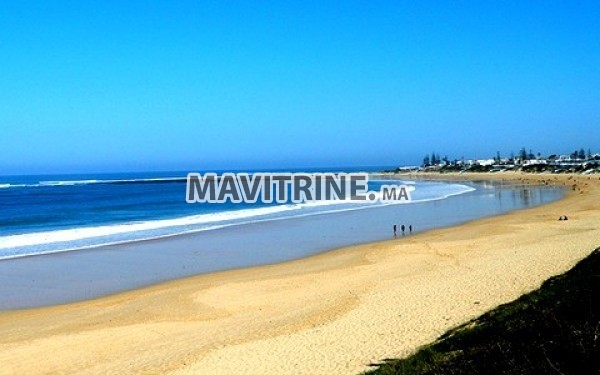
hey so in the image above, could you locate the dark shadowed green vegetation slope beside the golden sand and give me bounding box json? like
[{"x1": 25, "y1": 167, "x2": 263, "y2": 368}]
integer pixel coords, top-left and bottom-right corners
[{"x1": 367, "y1": 248, "x2": 600, "y2": 375}]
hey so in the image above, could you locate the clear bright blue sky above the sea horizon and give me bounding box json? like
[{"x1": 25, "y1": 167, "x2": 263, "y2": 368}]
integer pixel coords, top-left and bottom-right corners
[{"x1": 0, "y1": 0, "x2": 600, "y2": 174}]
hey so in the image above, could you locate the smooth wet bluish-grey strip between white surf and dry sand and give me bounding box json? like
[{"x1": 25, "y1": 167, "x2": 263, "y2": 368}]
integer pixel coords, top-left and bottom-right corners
[{"x1": 0, "y1": 181, "x2": 564, "y2": 310}]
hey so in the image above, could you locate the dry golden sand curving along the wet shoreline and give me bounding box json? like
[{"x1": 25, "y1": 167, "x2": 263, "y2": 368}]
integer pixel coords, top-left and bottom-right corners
[{"x1": 0, "y1": 173, "x2": 600, "y2": 374}]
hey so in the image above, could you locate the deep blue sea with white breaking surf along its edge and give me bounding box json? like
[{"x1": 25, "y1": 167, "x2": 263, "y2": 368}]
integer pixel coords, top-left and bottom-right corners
[{"x1": 0, "y1": 168, "x2": 474, "y2": 259}]
